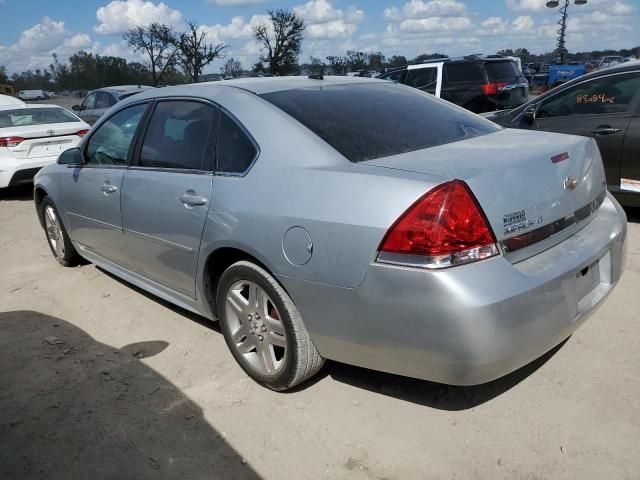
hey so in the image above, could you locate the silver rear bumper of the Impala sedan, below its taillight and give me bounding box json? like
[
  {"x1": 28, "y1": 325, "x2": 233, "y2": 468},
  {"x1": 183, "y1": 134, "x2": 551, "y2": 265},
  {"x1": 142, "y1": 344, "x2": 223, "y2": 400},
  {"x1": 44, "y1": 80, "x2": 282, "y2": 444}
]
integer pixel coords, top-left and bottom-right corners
[{"x1": 280, "y1": 195, "x2": 627, "y2": 385}]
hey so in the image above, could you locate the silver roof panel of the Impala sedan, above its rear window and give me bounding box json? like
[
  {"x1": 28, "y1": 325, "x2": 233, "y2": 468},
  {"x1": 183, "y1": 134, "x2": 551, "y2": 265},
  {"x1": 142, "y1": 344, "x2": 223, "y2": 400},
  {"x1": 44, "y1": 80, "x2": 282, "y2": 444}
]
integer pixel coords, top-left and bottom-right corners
[{"x1": 194, "y1": 75, "x2": 384, "y2": 95}]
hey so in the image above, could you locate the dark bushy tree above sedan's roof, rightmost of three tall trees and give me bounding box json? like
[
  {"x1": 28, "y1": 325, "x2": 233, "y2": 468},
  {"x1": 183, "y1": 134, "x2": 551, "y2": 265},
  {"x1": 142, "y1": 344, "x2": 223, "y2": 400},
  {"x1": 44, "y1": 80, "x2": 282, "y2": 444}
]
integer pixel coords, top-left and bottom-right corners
[{"x1": 253, "y1": 8, "x2": 305, "y2": 75}]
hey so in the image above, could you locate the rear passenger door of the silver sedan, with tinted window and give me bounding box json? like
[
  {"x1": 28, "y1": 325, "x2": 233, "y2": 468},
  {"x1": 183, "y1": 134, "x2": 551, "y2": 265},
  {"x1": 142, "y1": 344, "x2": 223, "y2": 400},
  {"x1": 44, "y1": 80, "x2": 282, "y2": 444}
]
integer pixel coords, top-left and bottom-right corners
[{"x1": 121, "y1": 99, "x2": 219, "y2": 298}]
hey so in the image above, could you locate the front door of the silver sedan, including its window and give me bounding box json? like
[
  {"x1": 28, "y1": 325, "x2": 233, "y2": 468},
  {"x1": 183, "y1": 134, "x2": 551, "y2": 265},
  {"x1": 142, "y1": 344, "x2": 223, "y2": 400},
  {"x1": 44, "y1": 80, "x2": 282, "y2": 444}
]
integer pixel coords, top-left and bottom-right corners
[{"x1": 62, "y1": 103, "x2": 147, "y2": 267}]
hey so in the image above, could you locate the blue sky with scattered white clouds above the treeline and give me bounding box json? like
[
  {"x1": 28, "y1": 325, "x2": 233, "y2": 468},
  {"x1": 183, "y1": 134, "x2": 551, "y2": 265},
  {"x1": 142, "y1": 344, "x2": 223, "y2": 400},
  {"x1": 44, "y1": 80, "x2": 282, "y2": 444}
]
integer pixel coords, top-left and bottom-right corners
[{"x1": 0, "y1": 0, "x2": 640, "y2": 73}]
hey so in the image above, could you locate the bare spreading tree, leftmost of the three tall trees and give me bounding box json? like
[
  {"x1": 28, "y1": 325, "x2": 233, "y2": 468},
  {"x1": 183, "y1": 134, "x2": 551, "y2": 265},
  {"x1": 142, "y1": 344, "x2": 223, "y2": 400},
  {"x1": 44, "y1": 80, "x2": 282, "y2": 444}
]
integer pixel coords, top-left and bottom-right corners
[{"x1": 122, "y1": 23, "x2": 179, "y2": 87}]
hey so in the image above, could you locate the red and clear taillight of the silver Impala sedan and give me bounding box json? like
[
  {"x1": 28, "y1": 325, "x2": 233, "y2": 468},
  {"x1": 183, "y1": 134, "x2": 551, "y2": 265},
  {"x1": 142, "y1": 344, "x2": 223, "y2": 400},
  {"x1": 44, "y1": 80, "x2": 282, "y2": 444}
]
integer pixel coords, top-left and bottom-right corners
[{"x1": 378, "y1": 180, "x2": 498, "y2": 268}]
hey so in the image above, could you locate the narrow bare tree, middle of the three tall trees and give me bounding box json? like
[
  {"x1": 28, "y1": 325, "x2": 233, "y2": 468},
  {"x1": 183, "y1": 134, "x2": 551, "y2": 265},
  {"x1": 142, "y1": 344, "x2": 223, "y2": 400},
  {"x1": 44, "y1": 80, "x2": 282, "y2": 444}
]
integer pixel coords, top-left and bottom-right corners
[{"x1": 177, "y1": 20, "x2": 227, "y2": 83}]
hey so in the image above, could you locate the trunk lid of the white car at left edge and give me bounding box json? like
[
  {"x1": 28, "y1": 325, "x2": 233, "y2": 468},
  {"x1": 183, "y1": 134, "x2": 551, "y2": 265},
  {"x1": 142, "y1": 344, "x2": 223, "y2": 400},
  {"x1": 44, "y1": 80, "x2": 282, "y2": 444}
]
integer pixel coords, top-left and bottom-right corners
[{"x1": 0, "y1": 123, "x2": 84, "y2": 159}]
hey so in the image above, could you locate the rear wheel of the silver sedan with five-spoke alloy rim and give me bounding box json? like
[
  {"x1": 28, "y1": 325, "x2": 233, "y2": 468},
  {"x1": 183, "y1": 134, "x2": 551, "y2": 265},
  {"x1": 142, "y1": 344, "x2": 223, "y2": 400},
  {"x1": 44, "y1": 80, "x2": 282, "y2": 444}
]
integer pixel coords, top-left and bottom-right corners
[{"x1": 216, "y1": 261, "x2": 324, "y2": 391}]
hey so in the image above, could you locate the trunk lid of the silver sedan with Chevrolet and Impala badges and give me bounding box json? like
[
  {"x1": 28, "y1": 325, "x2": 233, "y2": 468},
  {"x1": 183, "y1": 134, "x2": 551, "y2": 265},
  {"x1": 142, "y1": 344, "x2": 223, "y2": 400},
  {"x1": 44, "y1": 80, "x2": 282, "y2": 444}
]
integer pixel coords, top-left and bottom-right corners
[{"x1": 363, "y1": 129, "x2": 606, "y2": 261}]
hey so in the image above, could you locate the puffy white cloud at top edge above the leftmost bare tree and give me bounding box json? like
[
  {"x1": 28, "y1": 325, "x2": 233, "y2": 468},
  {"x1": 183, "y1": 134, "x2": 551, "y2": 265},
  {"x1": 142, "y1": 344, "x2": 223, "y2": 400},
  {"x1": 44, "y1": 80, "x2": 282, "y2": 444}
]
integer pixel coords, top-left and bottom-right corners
[{"x1": 93, "y1": 0, "x2": 183, "y2": 35}]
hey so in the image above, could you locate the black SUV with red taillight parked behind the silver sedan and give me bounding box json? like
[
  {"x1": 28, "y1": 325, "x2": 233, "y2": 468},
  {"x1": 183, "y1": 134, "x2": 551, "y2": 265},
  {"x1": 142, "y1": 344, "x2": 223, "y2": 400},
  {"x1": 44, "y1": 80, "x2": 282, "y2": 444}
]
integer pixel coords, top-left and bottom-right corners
[{"x1": 378, "y1": 55, "x2": 529, "y2": 113}]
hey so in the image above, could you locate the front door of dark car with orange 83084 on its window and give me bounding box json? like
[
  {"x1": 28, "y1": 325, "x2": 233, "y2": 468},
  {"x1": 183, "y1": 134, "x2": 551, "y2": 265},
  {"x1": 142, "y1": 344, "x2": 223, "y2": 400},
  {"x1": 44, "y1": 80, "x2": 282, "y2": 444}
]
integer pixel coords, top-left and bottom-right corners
[{"x1": 533, "y1": 72, "x2": 640, "y2": 192}]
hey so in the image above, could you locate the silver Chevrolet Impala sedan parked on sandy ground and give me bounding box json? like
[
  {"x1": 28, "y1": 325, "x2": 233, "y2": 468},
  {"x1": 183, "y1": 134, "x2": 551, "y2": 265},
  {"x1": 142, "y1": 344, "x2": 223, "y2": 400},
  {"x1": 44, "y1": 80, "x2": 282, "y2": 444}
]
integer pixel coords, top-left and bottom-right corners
[{"x1": 35, "y1": 77, "x2": 626, "y2": 390}]
